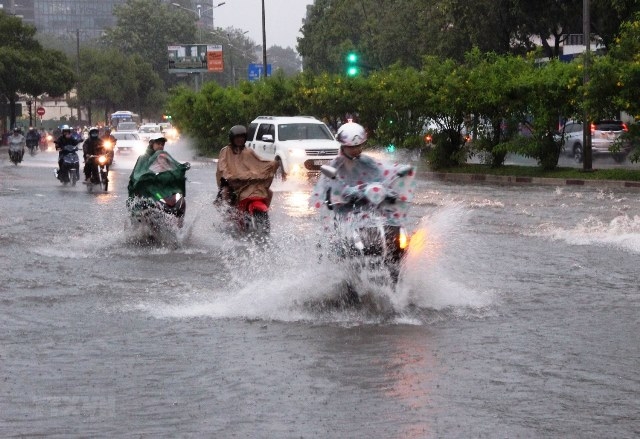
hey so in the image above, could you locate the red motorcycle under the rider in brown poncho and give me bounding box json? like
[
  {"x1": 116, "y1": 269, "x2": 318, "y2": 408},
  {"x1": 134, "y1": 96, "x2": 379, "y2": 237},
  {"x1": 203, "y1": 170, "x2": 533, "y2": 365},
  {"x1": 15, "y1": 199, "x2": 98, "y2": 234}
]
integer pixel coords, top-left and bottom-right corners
[{"x1": 214, "y1": 178, "x2": 271, "y2": 236}]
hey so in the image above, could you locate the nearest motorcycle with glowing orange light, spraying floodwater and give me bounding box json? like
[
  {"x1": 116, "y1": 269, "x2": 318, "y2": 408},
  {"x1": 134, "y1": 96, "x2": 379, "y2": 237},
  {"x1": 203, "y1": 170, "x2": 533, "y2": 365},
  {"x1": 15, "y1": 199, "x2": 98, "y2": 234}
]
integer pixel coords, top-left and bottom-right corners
[{"x1": 320, "y1": 165, "x2": 414, "y2": 296}]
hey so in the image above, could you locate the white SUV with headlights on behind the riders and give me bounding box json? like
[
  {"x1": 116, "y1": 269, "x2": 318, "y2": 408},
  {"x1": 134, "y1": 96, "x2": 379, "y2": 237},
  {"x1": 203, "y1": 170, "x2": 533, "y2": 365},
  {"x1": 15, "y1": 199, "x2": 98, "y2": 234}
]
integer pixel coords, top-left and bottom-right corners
[{"x1": 247, "y1": 116, "x2": 340, "y2": 180}]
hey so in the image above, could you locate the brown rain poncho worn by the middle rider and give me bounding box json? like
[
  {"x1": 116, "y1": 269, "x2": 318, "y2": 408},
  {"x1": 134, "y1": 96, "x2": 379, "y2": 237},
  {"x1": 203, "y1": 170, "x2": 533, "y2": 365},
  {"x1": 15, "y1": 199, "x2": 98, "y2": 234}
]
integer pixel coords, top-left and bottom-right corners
[{"x1": 216, "y1": 145, "x2": 278, "y2": 206}]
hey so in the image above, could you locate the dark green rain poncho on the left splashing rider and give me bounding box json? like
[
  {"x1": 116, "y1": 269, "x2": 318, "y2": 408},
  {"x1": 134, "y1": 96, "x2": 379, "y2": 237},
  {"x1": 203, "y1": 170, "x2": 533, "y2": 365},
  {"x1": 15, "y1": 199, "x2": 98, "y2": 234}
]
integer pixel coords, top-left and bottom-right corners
[{"x1": 127, "y1": 148, "x2": 189, "y2": 201}]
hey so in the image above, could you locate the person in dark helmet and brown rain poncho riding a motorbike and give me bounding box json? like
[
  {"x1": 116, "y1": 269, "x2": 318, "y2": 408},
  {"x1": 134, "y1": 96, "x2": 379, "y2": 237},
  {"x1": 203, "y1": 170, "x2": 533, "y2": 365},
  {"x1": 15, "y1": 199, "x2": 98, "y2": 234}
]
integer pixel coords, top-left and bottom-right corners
[{"x1": 216, "y1": 125, "x2": 279, "y2": 210}]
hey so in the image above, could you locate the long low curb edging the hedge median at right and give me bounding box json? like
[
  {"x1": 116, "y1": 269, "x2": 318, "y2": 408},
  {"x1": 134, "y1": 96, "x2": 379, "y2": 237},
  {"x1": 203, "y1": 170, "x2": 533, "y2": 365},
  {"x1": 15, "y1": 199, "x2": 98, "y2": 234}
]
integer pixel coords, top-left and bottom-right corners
[{"x1": 418, "y1": 172, "x2": 640, "y2": 189}]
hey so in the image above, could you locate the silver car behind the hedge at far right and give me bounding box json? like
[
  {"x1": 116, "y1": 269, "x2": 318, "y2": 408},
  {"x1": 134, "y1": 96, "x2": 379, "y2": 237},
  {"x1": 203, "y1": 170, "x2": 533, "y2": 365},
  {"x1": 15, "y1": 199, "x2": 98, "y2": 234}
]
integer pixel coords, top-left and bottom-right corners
[{"x1": 561, "y1": 120, "x2": 631, "y2": 163}]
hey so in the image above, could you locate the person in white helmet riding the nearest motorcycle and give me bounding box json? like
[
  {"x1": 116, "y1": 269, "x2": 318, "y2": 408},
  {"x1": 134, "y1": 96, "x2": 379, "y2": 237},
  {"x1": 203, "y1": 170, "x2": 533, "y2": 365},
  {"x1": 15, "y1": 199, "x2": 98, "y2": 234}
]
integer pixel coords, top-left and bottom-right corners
[{"x1": 310, "y1": 122, "x2": 385, "y2": 215}]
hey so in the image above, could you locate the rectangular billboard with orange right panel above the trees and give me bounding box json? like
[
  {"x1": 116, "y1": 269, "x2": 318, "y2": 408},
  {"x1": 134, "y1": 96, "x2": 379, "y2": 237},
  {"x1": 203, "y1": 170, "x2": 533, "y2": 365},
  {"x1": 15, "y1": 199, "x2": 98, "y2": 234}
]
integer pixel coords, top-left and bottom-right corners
[{"x1": 167, "y1": 44, "x2": 224, "y2": 73}]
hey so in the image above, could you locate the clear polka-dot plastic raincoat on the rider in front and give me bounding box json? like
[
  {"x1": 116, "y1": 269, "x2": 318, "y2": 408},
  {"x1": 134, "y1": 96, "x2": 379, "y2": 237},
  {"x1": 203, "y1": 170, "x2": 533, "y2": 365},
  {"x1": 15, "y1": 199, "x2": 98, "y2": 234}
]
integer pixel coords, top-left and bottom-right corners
[{"x1": 309, "y1": 154, "x2": 415, "y2": 225}]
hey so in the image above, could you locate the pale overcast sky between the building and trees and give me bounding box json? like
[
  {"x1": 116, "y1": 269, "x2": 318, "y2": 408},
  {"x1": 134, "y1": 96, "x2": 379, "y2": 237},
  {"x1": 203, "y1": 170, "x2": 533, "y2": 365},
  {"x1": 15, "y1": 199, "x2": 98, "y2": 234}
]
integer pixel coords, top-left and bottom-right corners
[{"x1": 209, "y1": 0, "x2": 314, "y2": 50}]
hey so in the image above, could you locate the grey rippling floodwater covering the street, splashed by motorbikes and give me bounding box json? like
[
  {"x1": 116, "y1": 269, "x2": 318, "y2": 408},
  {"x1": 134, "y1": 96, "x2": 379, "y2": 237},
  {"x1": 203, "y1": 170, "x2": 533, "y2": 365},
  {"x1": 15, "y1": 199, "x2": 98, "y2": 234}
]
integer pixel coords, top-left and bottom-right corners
[{"x1": 0, "y1": 145, "x2": 640, "y2": 438}]
